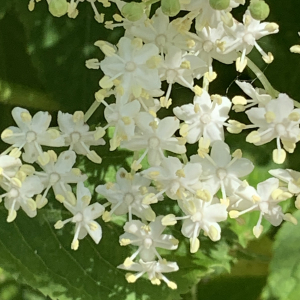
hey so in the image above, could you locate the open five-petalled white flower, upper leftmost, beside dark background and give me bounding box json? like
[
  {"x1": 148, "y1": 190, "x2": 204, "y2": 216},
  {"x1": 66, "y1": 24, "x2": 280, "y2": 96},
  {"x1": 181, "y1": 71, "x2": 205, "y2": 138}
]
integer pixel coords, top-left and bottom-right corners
[{"x1": 1, "y1": 107, "x2": 64, "y2": 164}]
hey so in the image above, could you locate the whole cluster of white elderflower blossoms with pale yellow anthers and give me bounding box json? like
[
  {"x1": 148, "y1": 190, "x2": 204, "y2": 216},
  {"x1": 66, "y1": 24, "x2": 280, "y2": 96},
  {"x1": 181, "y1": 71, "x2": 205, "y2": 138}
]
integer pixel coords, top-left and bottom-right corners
[{"x1": 4, "y1": 0, "x2": 300, "y2": 289}]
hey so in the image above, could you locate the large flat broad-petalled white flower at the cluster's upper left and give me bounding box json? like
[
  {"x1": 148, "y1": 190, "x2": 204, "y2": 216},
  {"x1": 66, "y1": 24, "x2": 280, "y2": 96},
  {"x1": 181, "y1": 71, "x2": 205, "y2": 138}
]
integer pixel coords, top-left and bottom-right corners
[{"x1": 100, "y1": 37, "x2": 161, "y2": 97}]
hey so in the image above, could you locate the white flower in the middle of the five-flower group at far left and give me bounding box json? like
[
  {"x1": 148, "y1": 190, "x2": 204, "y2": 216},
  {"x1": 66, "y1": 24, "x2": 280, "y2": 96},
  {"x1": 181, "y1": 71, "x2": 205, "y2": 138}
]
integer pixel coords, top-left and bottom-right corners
[{"x1": 35, "y1": 150, "x2": 87, "y2": 205}]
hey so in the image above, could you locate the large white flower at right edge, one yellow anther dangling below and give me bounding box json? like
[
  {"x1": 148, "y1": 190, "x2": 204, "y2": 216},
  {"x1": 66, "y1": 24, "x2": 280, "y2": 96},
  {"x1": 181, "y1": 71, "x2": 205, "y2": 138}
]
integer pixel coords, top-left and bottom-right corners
[{"x1": 246, "y1": 94, "x2": 300, "y2": 163}]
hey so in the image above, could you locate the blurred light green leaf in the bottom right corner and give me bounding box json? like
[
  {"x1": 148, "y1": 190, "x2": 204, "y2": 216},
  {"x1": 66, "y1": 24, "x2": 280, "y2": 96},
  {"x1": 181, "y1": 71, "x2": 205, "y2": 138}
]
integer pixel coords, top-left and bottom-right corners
[{"x1": 263, "y1": 211, "x2": 300, "y2": 300}]
